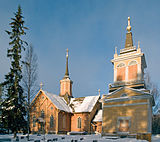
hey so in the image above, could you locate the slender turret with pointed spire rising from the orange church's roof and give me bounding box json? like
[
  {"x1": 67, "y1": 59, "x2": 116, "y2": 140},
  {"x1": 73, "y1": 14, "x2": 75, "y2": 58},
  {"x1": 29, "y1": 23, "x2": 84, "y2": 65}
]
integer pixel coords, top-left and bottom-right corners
[{"x1": 60, "y1": 49, "x2": 73, "y2": 97}]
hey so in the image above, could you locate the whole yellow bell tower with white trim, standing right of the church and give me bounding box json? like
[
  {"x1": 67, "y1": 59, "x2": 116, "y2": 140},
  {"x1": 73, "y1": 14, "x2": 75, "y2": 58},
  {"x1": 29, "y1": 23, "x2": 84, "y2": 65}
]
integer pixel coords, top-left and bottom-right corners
[{"x1": 102, "y1": 17, "x2": 154, "y2": 135}]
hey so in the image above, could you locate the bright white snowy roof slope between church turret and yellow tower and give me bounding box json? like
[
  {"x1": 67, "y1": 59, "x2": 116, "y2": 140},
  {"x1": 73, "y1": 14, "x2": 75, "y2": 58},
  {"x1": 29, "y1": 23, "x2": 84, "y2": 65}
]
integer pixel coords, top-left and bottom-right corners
[{"x1": 70, "y1": 96, "x2": 100, "y2": 112}]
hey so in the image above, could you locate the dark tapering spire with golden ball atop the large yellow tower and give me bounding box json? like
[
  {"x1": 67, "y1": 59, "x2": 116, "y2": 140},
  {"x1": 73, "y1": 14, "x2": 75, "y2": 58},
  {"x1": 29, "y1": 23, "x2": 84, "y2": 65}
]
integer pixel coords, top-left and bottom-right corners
[{"x1": 125, "y1": 17, "x2": 133, "y2": 48}]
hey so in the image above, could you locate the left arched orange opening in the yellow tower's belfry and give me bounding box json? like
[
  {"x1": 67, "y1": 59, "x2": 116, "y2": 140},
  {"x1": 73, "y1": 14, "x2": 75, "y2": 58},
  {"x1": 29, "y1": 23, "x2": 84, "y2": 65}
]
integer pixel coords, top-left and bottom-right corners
[{"x1": 117, "y1": 63, "x2": 126, "y2": 81}]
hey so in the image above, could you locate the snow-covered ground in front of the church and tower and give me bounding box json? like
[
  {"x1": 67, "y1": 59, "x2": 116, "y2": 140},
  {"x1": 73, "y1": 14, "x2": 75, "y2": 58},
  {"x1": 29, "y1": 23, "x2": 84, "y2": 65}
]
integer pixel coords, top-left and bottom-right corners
[{"x1": 0, "y1": 134, "x2": 160, "y2": 142}]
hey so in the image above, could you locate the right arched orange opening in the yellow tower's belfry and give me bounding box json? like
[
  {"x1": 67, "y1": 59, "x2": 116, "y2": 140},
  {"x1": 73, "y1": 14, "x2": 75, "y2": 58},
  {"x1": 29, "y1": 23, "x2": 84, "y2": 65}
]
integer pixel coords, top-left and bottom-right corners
[{"x1": 128, "y1": 60, "x2": 138, "y2": 81}]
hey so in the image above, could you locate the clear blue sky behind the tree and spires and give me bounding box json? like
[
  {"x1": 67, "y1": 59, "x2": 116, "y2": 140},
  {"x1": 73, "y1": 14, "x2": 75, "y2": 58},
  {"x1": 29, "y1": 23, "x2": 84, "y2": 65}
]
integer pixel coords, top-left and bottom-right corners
[{"x1": 0, "y1": 0, "x2": 160, "y2": 97}]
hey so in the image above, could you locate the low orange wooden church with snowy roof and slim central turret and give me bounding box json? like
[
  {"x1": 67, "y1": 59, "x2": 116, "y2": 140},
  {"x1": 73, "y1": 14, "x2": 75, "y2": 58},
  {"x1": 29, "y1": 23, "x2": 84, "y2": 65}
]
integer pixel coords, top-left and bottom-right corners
[{"x1": 30, "y1": 49, "x2": 102, "y2": 134}]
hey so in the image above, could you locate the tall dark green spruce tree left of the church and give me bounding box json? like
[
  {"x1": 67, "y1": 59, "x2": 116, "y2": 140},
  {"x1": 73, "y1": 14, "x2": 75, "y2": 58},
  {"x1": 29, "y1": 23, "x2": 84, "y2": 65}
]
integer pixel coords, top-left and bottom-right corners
[{"x1": 2, "y1": 6, "x2": 27, "y2": 137}]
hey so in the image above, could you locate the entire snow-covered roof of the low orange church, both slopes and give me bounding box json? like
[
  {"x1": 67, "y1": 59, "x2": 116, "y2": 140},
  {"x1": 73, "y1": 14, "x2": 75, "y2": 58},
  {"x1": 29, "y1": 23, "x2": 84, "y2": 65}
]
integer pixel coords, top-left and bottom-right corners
[{"x1": 31, "y1": 90, "x2": 100, "y2": 113}]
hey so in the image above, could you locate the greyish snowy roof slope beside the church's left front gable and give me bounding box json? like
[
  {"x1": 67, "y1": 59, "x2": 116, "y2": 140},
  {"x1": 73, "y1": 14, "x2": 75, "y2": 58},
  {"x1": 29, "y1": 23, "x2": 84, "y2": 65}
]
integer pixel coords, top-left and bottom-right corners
[{"x1": 43, "y1": 91, "x2": 72, "y2": 112}]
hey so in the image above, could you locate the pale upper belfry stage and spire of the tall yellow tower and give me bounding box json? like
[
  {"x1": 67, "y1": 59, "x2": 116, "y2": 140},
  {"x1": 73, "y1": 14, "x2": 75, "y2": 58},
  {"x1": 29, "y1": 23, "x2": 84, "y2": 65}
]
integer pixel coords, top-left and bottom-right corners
[{"x1": 109, "y1": 17, "x2": 147, "y2": 92}]
